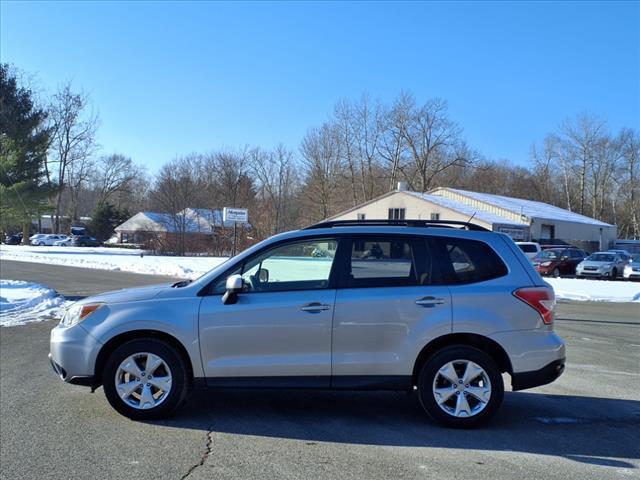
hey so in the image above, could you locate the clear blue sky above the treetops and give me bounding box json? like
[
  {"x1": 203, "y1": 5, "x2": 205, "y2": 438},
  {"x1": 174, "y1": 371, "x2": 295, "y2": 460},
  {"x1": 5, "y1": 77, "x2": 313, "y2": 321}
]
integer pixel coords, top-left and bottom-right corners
[{"x1": 0, "y1": 1, "x2": 640, "y2": 172}]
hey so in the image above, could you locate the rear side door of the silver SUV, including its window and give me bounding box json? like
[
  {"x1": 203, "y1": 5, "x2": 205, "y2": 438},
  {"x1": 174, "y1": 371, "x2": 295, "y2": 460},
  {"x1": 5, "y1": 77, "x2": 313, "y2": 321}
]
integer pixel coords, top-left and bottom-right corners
[{"x1": 332, "y1": 234, "x2": 452, "y2": 387}]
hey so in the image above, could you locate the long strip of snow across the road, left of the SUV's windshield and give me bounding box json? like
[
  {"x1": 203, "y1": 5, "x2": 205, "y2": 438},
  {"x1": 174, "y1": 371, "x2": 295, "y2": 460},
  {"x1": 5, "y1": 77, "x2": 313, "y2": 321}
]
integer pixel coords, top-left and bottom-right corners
[{"x1": 0, "y1": 245, "x2": 226, "y2": 279}]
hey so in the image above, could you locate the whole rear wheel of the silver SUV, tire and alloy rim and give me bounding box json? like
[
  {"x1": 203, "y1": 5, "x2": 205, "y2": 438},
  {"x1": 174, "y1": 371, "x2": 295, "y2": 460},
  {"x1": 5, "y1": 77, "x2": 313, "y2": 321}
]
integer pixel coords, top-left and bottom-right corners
[{"x1": 418, "y1": 346, "x2": 504, "y2": 428}]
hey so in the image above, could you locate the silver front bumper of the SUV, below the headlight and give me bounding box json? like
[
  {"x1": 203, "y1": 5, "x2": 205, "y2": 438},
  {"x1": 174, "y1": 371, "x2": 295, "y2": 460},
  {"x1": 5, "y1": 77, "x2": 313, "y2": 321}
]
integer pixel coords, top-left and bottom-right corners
[{"x1": 49, "y1": 324, "x2": 102, "y2": 386}]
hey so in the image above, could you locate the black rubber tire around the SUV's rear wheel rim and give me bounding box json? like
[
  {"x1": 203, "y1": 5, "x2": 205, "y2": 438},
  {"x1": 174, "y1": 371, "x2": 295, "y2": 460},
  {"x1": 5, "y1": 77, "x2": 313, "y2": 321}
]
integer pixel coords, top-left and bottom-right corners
[{"x1": 418, "y1": 345, "x2": 504, "y2": 428}]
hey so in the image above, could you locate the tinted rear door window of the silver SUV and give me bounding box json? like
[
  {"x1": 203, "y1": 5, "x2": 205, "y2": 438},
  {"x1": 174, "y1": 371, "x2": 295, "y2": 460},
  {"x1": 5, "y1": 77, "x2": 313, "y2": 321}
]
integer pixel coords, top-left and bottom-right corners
[{"x1": 346, "y1": 237, "x2": 431, "y2": 287}]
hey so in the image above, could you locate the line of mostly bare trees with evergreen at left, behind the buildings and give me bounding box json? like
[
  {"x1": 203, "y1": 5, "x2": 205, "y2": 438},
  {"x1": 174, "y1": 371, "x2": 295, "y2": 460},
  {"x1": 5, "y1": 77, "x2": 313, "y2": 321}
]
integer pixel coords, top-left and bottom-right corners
[{"x1": 0, "y1": 65, "x2": 640, "y2": 251}]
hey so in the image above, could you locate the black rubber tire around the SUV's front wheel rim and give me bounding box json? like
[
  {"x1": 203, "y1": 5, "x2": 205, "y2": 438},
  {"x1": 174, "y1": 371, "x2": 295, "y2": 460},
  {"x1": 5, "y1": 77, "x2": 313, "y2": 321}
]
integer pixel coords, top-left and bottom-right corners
[{"x1": 102, "y1": 338, "x2": 191, "y2": 420}]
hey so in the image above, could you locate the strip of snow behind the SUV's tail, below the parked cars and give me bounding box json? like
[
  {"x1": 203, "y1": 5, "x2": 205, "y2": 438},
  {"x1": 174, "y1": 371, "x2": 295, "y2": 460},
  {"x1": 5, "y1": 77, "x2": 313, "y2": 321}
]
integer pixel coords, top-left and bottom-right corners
[{"x1": 545, "y1": 278, "x2": 640, "y2": 302}]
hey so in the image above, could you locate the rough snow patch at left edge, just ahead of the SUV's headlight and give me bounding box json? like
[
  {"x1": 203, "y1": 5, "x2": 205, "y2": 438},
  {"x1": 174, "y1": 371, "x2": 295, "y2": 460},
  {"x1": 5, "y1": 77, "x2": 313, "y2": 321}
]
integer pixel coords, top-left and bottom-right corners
[{"x1": 0, "y1": 280, "x2": 69, "y2": 327}]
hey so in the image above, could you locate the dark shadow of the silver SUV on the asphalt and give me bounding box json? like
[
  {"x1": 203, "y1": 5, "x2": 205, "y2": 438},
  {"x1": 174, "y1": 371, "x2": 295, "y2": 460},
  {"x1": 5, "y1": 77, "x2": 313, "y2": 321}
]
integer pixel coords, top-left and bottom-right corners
[{"x1": 146, "y1": 390, "x2": 640, "y2": 468}]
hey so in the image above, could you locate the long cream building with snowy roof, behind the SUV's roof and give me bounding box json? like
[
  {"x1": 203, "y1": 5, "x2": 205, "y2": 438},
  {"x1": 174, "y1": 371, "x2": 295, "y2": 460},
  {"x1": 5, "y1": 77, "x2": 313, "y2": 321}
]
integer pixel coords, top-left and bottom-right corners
[{"x1": 330, "y1": 185, "x2": 617, "y2": 251}]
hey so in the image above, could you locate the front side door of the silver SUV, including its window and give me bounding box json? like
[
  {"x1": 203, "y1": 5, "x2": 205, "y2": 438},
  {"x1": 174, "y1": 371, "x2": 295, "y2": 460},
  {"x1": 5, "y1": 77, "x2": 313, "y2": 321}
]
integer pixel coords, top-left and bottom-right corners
[{"x1": 200, "y1": 238, "x2": 338, "y2": 387}]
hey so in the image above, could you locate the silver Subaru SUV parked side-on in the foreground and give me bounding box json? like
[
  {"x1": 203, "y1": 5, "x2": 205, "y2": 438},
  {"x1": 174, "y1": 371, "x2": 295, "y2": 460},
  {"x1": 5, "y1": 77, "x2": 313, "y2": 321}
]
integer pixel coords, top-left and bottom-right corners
[{"x1": 49, "y1": 220, "x2": 565, "y2": 427}]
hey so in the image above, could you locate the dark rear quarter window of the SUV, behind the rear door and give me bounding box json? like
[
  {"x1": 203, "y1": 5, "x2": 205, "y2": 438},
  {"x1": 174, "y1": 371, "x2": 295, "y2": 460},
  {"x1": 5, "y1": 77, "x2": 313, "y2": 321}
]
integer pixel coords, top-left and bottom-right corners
[{"x1": 434, "y1": 237, "x2": 508, "y2": 284}]
